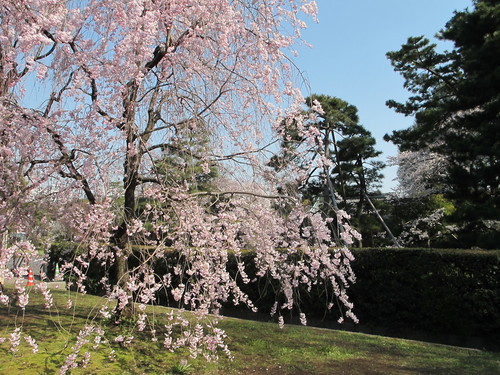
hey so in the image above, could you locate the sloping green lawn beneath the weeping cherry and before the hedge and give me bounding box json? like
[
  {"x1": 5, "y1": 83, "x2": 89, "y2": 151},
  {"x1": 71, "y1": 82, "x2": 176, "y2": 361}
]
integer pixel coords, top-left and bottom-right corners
[{"x1": 0, "y1": 291, "x2": 500, "y2": 375}]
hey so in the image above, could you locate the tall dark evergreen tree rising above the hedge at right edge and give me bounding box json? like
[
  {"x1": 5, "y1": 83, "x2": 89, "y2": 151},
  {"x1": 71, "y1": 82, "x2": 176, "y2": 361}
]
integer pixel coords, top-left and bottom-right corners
[{"x1": 385, "y1": 0, "x2": 500, "y2": 246}]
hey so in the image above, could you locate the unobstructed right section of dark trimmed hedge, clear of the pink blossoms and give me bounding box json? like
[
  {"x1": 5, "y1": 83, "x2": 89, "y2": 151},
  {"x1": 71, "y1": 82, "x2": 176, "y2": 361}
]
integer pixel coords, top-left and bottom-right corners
[{"x1": 349, "y1": 249, "x2": 500, "y2": 348}]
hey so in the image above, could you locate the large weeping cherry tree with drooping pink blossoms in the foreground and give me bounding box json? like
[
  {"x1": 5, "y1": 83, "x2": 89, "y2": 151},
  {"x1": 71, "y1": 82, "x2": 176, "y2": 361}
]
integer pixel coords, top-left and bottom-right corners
[{"x1": 0, "y1": 0, "x2": 356, "y2": 373}]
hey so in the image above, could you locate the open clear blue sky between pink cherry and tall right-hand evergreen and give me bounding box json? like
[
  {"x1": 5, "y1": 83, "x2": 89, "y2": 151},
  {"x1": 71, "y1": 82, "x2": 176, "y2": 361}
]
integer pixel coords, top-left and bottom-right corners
[{"x1": 296, "y1": 0, "x2": 472, "y2": 192}]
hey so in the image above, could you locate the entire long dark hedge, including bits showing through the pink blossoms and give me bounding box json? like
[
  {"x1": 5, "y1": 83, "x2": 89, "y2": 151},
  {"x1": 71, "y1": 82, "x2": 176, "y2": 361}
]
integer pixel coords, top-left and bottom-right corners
[{"x1": 49, "y1": 243, "x2": 500, "y2": 349}]
